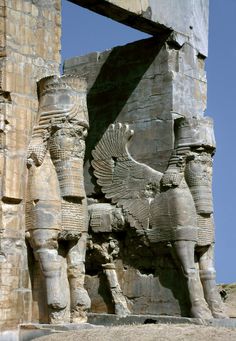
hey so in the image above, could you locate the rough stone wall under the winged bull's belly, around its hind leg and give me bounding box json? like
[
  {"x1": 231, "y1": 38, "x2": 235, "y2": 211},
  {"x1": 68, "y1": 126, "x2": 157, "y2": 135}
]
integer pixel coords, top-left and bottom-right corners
[{"x1": 85, "y1": 258, "x2": 189, "y2": 316}]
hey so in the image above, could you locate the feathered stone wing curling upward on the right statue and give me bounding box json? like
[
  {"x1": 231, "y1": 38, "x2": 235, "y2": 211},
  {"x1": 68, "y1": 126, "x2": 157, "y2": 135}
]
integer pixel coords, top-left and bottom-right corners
[{"x1": 92, "y1": 123, "x2": 162, "y2": 229}]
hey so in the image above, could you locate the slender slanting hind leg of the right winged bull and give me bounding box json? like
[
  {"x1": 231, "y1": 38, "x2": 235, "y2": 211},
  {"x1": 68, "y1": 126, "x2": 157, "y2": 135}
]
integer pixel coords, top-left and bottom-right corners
[{"x1": 103, "y1": 263, "x2": 130, "y2": 316}]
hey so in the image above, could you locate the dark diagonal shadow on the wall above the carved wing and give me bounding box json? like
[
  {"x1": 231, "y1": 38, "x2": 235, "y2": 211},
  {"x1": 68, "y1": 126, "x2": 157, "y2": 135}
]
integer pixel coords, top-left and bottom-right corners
[{"x1": 85, "y1": 36, "x2": 170, "y2": 162}]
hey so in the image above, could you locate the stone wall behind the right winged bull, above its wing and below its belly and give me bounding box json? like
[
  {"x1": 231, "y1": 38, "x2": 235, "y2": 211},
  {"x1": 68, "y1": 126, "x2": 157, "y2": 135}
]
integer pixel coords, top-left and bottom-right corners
[{"x1": 64, "y1": 33, "x2": 206, "y2": 316}]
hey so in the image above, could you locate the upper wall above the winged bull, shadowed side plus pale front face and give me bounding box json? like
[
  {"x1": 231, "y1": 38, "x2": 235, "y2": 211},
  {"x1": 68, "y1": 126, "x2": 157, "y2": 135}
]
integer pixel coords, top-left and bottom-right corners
[{"x1": 64, "y1": 35, "x2": 206, "y2": 195}]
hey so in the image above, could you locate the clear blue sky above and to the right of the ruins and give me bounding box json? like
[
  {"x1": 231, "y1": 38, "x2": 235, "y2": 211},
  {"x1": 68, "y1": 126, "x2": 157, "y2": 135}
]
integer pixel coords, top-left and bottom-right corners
[{"x1": 62, "y1": 0, "x2": 236, "y2": 283}]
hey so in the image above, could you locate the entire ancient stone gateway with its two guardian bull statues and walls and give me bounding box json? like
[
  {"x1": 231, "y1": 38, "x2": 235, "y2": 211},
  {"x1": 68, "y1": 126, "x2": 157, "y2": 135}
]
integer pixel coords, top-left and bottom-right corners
[{"x1": 0, "y1": 0, "x2": 230, "y2": 334}]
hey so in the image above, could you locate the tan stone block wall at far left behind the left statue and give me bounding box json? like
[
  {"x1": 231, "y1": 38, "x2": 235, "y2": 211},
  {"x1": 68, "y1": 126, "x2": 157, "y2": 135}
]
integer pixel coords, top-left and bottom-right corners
[{"x1": 0, "y1": 0, "x2": 61, "y2": 329}]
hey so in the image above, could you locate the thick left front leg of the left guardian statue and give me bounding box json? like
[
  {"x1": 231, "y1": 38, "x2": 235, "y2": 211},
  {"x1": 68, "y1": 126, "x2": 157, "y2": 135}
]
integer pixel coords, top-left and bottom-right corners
[{"x1": 31, "y1": 229, "x2": 67, "y2": 310}]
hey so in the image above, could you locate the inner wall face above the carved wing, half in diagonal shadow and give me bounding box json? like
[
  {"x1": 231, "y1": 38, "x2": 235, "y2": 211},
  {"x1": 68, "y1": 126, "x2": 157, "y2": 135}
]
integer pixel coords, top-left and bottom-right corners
[{"x1": 64, "y1": 38, "x2": 173, "y2": 194}]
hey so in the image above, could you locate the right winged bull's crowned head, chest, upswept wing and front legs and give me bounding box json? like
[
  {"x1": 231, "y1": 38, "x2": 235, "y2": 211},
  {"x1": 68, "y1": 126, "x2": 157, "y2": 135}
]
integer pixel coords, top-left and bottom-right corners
[{"x1": 92, "y1": 117, "x2": 225, "y2": 319}]
